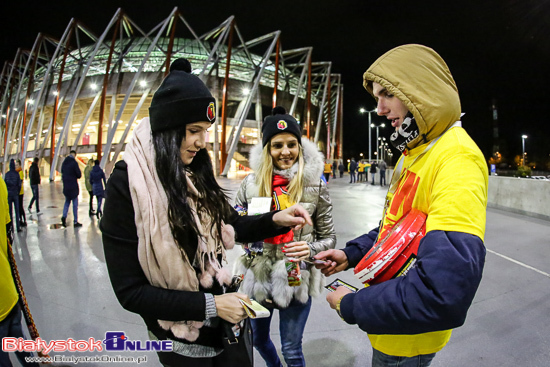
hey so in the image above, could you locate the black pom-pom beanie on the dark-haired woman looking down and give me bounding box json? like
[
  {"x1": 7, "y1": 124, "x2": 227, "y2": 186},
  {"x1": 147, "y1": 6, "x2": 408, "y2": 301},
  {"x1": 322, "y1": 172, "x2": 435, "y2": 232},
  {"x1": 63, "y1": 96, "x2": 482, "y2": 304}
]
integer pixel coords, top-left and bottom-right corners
[{"x1": 149, "y1": 59, "x2": 216, "y2": 131}]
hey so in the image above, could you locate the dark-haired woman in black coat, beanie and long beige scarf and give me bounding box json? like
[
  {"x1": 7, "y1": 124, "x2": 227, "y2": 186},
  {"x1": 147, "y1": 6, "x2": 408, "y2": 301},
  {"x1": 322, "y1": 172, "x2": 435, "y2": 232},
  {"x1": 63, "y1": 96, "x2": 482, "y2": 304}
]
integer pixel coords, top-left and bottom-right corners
[{"x1": 100, "y1": 59, "x2": 311, "y2": 367}]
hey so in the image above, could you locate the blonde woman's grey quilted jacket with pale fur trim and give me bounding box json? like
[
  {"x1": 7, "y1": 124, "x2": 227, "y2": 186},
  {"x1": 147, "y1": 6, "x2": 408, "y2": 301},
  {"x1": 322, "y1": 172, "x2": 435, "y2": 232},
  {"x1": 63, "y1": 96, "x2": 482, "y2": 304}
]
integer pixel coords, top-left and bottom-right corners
[{"x1": 234, "y1": 139, "x2": 336, "y2": 308}]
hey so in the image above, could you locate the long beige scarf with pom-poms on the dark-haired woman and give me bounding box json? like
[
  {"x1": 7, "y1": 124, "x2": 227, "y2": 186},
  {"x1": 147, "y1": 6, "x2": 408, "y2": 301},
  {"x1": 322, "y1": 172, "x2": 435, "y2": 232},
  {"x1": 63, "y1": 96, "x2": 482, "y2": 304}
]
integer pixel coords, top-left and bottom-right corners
[{"x1": 124, "y1": 118, "x2": 235, "y2": 341}]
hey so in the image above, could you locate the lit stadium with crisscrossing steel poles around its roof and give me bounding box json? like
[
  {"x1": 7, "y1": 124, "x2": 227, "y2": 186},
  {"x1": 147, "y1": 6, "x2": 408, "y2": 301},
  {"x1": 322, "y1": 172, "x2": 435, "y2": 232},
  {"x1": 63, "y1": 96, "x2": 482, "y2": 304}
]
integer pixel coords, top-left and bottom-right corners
[{"x1": 0, "y1": 7, "x2": 343, "y2": 180}]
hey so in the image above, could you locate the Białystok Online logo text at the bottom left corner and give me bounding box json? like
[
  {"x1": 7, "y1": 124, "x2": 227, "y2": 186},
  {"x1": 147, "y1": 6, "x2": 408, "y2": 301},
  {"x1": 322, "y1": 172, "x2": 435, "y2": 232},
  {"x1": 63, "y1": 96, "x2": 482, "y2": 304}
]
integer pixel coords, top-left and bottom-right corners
[{"x1": 2, "y1": 331, "x2": 172, "y2": 354}]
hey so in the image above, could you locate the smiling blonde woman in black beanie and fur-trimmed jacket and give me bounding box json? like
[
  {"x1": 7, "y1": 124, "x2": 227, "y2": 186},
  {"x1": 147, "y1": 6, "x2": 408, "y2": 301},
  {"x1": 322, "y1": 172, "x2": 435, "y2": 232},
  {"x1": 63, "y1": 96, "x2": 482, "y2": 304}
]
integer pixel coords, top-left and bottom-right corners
[{"x1": 236, "y1": 107, "x2": 336, "y2": 366}]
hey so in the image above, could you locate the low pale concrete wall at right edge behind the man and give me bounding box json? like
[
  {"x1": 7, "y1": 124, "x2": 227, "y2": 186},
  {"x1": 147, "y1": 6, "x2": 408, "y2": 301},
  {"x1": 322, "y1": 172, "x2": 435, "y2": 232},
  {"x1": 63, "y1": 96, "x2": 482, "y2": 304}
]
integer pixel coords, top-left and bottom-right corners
[{"x1": 488, "y1": 176, "x2": 550, "y2": 220}]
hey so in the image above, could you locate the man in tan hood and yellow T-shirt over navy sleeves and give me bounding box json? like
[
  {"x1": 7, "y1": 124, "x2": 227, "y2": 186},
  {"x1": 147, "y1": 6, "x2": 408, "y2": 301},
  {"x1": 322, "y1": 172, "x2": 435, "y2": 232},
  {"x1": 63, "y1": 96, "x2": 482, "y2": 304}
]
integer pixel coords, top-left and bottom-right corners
[{"x1": 316, "y1": 45, "x2": 488, "y2": 367}]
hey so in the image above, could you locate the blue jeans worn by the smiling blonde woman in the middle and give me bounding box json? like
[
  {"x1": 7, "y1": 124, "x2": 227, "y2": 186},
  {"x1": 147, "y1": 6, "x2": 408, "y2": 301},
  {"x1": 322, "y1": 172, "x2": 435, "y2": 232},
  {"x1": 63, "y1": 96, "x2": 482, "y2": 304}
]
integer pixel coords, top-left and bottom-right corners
[{"x1": 250, "y1": 297, "x2": 311, "y2": 367}]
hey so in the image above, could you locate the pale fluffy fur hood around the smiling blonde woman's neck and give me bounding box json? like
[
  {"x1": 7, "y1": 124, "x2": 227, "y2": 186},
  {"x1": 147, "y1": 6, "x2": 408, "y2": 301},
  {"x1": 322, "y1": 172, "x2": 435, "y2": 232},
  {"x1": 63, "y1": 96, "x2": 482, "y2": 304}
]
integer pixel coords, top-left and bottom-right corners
[{"x1": 249, "y1": 139, "x2": 325, "y2": 185}]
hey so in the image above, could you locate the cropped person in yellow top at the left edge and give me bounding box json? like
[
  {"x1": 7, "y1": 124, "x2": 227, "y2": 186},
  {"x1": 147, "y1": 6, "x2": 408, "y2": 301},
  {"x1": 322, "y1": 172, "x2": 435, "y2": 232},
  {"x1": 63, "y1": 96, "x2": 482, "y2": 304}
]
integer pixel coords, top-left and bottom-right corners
[{"x1": 0, "y1": 177, "x2": 39, "y2": 367}]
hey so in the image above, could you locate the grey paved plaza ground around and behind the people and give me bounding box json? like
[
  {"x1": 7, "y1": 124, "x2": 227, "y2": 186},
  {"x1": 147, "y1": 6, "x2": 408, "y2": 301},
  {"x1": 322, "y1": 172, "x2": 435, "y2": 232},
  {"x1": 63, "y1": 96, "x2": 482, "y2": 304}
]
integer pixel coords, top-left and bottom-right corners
[{"x1": 8, "y1": 177, "x2": 550, "y2": 367}]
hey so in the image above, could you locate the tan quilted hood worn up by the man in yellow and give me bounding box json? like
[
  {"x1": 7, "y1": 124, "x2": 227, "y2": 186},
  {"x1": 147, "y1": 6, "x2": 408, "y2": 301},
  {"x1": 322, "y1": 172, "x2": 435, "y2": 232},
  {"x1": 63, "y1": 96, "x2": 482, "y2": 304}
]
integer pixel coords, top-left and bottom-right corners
[{"x1": 363, "y1": 44, "x2": 461, "y2": 148}]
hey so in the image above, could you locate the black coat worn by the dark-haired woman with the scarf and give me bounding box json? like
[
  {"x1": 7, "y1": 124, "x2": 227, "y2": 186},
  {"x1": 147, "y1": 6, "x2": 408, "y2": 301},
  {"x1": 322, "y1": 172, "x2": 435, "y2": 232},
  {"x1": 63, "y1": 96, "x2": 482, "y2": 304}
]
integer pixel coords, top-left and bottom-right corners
[{"x1": 100, "y1": 161, "x2": 289, "y2": 354}]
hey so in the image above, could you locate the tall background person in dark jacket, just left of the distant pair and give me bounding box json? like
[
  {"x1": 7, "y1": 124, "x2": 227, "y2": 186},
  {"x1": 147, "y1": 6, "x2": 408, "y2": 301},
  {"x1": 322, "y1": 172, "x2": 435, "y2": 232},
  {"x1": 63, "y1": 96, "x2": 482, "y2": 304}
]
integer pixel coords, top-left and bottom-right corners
[{"x1": 61, "y1": 150, "x2": 82, "y2": 227}]
